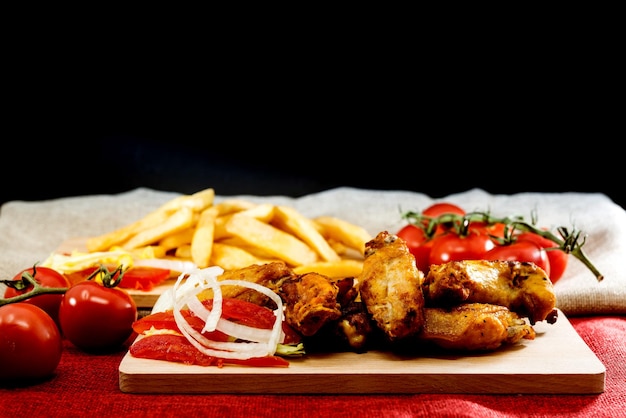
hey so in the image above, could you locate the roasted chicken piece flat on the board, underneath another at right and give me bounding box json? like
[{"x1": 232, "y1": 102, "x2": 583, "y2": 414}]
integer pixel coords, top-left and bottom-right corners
[{"x1": 419, "y1": 303, "x2": 535, "y2": 351}]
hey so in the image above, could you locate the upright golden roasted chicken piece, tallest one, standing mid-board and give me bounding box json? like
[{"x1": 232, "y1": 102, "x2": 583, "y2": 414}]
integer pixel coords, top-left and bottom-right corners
[{"x1": 359, "y1": 231, "x2": 424, "y2": 341}]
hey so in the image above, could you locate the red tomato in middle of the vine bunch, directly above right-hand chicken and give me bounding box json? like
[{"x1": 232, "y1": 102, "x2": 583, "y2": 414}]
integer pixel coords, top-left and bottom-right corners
[{"x1": 428, "y1": 231, "x2": 495, "y2": 265}]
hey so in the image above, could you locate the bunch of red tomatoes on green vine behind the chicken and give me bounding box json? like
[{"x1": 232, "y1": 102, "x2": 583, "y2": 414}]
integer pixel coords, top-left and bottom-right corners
[{"x1": 396, "y1": 202, "x2": 603, "y2": 283}]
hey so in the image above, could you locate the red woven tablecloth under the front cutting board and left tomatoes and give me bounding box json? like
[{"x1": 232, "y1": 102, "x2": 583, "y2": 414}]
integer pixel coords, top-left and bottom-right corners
[{"x1": 0, "y1": 316, "x2": 626, "y2": 418}]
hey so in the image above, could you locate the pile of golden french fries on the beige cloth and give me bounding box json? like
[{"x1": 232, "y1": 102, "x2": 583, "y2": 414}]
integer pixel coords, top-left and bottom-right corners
[{"x1": 86, "y1": 188, "x2": 372, "y2": 278}]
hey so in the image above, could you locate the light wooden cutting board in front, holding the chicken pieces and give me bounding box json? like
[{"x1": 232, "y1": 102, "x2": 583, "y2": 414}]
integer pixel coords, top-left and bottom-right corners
[{"x1": 119, "y1": 312, "x2": 606, "y2": 394}]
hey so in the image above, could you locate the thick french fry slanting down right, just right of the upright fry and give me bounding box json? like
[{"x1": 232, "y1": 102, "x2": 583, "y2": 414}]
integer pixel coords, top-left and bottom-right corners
[{"x1": 224, "y1": 214, "x2": 318, "y2": 266}]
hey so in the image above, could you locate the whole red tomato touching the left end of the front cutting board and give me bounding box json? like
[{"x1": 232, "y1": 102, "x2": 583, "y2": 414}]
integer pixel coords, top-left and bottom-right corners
[{"x1": 59, "y1": 280, "x2": 137, "y2": 351}]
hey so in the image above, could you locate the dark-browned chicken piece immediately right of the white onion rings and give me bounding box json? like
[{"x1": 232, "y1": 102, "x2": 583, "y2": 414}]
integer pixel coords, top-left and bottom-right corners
[{"x1": 277, "y1": 273, "x2": 341, "y2": 337}]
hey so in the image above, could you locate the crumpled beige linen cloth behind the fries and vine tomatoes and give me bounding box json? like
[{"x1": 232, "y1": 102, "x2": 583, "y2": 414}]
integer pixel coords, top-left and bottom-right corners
[{"x1": 0, "y1": 187, "x2": 626, "y2": 316}]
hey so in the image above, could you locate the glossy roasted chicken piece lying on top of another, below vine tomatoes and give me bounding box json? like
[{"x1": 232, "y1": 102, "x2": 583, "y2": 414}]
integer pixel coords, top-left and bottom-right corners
[{"x1": 422, "y1": 260, "x2": 557, "y2": 324}]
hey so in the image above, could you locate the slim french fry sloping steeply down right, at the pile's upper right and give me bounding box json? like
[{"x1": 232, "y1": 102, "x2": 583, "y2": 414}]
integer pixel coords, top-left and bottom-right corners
[{"x1": 272, "y1": 206, "x2": 340, "y2": 261}]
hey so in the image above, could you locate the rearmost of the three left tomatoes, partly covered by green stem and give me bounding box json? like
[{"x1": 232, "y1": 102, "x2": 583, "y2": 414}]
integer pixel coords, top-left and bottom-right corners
[{"x1": 4, "y1": 266, "x2": 70, "y2": 326}]
